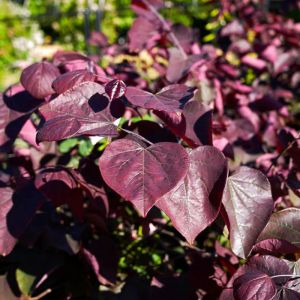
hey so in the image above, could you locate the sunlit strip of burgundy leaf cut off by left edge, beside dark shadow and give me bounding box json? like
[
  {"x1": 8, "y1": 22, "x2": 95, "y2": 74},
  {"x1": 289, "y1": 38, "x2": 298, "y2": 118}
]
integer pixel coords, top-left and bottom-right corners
[{"x1": 0, "y1": 187, "x2": 16, "y2": 256}]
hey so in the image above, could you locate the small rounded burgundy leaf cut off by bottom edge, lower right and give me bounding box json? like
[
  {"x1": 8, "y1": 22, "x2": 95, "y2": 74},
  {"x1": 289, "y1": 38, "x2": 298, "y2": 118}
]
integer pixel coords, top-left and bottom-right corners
[{"x1": 233, "y1": 271, "x2": 276, "y2": 300}]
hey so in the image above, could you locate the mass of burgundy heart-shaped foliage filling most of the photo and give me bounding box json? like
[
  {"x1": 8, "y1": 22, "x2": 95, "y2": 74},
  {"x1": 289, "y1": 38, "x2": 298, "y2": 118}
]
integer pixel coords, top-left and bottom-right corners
[{"x1": 0, "y1": 0, "x2": 300, "y2": 300}]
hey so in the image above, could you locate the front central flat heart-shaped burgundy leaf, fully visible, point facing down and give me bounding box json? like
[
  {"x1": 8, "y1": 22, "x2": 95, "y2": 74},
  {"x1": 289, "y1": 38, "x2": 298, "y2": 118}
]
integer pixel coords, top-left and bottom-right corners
[{"x1": 99, "y1": 139, "x2": 189, "y2": 216}]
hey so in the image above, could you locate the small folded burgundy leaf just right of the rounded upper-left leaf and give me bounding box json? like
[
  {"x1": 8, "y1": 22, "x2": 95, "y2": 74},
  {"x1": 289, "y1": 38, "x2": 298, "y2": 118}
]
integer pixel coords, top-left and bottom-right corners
[{"x1": 52, "y1": 69, "x2": 96, "y2": 94}]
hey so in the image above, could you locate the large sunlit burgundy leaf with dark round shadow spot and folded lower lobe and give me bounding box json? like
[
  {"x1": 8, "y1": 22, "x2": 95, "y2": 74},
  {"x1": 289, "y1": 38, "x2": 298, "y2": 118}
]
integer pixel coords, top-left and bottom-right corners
[{"x1": 37, "y1": 82, "x2": 122, "y2": 142}]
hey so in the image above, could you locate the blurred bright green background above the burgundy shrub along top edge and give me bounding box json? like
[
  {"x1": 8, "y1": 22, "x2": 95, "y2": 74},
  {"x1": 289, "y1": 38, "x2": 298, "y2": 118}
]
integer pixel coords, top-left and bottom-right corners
[{"x1": 0, "y1": 0, "x2": 300, "y2": 90}]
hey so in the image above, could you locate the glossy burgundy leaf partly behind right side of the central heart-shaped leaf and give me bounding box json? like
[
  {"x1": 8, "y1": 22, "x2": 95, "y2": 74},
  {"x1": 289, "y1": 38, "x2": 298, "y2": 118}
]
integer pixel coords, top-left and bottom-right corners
[{"x1": 156, "y1": 146, "x2": 227, "y2": 244}]
